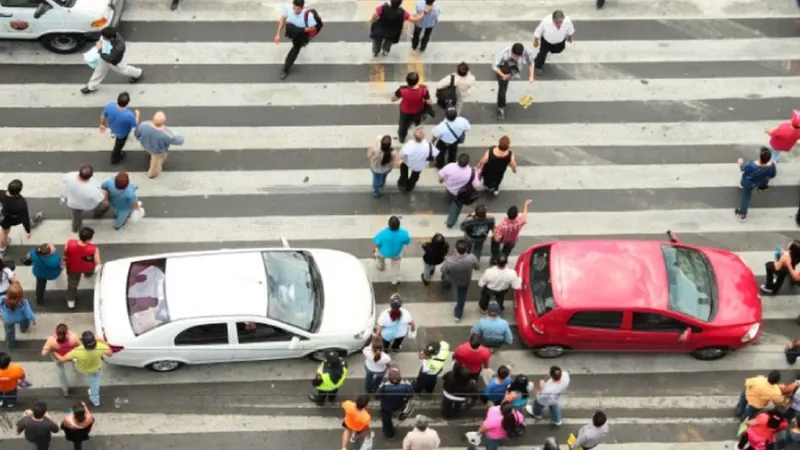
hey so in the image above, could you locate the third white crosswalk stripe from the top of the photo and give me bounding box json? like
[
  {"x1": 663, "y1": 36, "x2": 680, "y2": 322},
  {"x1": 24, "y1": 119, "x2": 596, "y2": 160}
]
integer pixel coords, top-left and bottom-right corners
[{"x1": 6, "y1": 77, "x2": 800, "y2": 107}]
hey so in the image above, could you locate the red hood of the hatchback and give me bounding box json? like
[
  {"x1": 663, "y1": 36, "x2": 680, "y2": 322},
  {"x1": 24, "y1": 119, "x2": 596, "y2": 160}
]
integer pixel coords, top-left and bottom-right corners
[{"x1": 703, "y1": 248, "x2": 763, "y2": 326}]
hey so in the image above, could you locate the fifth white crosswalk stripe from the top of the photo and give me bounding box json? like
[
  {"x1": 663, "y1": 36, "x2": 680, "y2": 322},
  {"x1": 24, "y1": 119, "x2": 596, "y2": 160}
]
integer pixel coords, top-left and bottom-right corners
[{"x1": 7, "y1": 164, "x2": 800, "y2": 198}]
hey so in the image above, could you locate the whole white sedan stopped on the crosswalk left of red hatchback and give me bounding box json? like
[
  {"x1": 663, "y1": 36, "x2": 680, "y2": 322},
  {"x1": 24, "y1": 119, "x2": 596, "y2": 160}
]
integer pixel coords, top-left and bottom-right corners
[{"x1": 94, "y1": 239, "x2": 375, "y2": 372}]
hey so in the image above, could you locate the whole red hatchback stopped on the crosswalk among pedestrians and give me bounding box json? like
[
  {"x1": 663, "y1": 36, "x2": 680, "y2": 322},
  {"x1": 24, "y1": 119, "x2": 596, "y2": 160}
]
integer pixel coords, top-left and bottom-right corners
[{"x1": 515, "y1": 232, "x2": 762, "y2": 360}]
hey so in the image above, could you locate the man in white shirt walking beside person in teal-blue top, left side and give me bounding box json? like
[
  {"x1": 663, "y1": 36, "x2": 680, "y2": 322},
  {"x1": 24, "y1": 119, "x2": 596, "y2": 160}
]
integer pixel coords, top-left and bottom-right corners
[{"x1": 61, "y1": 164, "x2": 111, "y2": 233}]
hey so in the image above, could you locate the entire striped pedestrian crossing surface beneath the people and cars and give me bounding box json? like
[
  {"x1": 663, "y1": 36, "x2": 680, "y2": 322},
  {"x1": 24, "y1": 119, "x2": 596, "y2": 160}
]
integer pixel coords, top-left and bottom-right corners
[{"x1": 0, "y1": 0, "x2": 800, "y2": 450}]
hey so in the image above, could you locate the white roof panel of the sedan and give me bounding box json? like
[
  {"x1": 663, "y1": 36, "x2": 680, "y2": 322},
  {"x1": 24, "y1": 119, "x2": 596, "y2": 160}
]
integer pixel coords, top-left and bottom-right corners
[{"x1": 165, "y1": 251, "x2": 268, "y2": 321}]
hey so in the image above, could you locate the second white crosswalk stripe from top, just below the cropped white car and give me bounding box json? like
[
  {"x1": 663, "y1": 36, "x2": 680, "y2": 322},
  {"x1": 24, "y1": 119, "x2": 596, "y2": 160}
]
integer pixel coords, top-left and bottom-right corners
[{"x1": 0, "y1": 37, "x2": 800, "y2": 64}]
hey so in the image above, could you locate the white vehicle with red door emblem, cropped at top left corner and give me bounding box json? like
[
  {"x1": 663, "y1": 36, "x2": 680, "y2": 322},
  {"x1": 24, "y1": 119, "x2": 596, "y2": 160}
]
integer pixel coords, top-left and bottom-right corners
[{"x1": 0, "y1": 0, "x2": 125, "y2": 54}]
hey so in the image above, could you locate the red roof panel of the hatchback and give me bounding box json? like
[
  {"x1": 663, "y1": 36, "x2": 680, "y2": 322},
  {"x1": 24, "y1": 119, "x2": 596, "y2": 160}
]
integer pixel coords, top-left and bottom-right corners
[{"x1": 550, "y1": 240, "x2": 669, "y2": 311}]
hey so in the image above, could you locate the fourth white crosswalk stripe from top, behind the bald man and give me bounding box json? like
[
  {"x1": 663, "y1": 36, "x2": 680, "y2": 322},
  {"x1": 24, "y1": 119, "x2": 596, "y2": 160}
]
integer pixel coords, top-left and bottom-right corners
[{"x1": 0, "y1": 123, "x2": 778, "y2": 152}]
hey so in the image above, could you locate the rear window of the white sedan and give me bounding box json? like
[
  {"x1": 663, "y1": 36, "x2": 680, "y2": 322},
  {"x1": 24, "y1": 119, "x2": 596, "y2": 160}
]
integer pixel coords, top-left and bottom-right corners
[{"x1": 127, "y1": 258, "x2": 170, "y2": 336}]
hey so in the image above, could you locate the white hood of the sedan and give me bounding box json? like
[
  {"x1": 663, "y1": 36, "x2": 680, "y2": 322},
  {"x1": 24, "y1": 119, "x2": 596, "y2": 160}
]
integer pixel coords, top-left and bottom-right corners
[{"x1": 309, "y1": 249, "x2": 375, "y2": 334}]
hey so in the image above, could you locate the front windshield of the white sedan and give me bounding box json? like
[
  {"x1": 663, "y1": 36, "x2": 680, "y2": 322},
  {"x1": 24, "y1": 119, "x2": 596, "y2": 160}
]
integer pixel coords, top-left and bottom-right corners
[{"x1": 262, "y1": 251, "x2": 321, "y2": 331}]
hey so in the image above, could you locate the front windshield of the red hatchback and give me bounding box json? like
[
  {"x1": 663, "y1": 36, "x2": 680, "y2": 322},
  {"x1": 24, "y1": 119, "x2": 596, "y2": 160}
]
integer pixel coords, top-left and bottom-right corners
[{"x1": 661, "y1": 245, "x2": 714, "y2": 322}]
